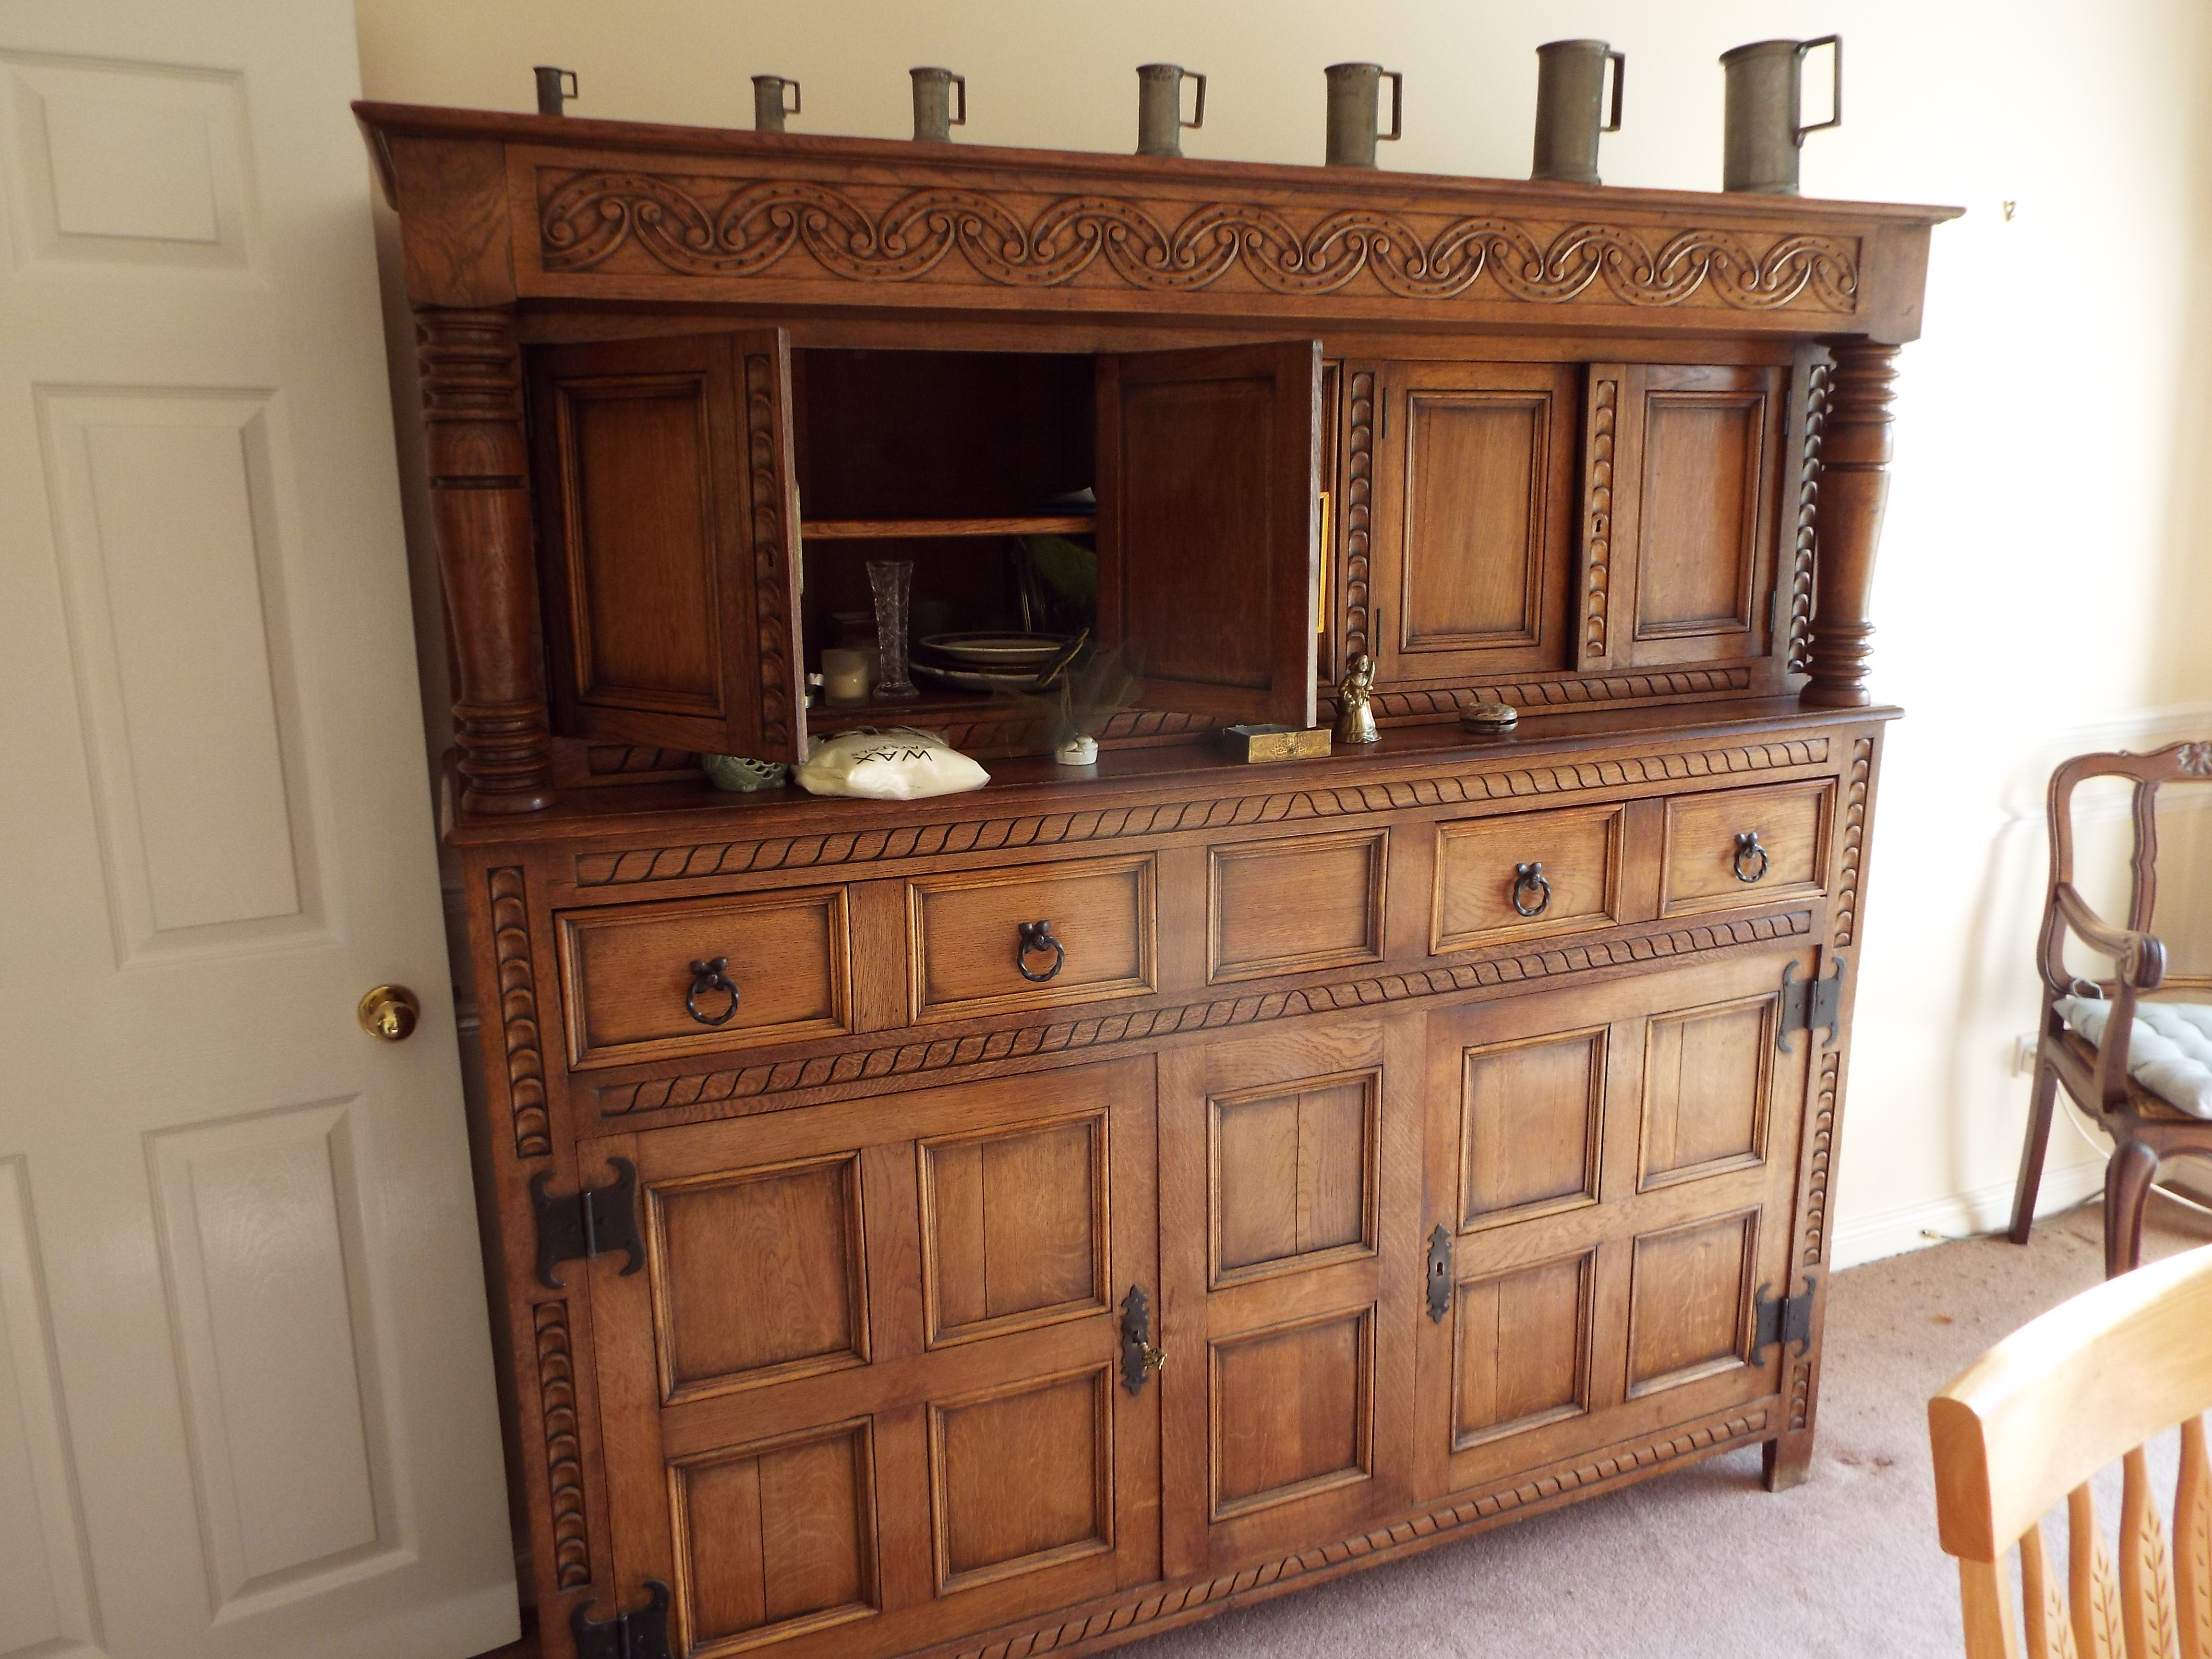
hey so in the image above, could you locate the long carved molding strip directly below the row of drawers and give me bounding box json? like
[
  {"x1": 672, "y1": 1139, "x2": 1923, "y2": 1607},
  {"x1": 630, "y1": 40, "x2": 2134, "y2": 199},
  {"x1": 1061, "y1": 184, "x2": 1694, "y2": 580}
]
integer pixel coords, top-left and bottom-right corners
[{"x1": 600, "y1": 911, "x2": 1812, "y2": 1117}]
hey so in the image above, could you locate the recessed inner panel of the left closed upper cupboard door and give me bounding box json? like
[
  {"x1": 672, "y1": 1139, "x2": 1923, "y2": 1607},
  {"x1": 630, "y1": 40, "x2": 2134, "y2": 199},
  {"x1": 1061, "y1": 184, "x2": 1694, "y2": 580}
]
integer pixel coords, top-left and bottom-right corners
[{"x1": 1400, "y1": 387, "x2": 1551, "y2": 655}]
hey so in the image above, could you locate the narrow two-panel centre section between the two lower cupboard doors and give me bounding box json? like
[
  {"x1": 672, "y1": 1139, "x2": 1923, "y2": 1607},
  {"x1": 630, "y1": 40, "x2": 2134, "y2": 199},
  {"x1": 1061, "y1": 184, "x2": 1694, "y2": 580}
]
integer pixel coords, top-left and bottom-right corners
[{"x1": 1159, "y1": 1020, "x2": 1422, "y2": 1577}]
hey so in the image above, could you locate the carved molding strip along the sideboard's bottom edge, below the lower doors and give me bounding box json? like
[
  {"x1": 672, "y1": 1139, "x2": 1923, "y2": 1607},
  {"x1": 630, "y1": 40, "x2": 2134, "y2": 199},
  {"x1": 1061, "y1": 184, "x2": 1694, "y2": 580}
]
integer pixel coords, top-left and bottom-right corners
[{"x1": 960, "y1": 1411, "x2": 1767, "y2": 1659}]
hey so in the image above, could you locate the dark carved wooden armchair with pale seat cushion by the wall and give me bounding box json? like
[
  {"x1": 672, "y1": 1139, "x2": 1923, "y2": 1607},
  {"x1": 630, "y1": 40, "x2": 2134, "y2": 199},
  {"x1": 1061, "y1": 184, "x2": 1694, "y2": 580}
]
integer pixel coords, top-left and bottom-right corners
[{"x1": 2011, "y1": 741, "x2": 2212, "y2": 1276}]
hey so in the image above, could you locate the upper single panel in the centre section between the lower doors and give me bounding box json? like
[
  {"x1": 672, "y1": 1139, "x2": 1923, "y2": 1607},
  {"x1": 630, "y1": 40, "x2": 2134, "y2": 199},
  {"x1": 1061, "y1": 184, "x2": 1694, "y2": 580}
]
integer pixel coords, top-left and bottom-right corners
[{"x1": 1210, "y1": 1073, "x2": 1382, "y2": 1285}]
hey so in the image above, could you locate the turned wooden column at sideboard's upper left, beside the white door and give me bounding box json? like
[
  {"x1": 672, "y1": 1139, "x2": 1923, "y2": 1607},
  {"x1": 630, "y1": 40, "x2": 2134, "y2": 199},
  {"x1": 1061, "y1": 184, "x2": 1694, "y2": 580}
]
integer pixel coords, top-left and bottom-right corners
[{"x1": 416, "y1": 305, "x2": 553, "y2": 812}]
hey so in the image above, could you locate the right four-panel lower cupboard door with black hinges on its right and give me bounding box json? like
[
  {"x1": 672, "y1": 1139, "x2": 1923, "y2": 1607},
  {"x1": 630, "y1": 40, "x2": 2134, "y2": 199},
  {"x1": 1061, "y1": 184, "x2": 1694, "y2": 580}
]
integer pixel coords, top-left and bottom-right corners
[{"x1": 1418, "y1": 949, "x2": 1814, "y2": 1498}]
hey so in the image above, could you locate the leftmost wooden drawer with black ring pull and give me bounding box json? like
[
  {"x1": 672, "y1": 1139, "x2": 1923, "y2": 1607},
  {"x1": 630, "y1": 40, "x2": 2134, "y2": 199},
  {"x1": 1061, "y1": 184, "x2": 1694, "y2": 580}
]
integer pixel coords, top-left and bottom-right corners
[{"x1": 557, "y1": 887, "x2": 852, "y2": 1070}]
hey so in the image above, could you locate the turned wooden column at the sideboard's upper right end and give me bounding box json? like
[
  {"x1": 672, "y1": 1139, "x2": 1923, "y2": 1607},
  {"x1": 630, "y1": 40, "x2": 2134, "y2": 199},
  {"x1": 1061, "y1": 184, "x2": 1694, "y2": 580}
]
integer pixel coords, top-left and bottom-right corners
[{"x1": 1798, "y1": 341, "x2": 1898, "y2": 708}]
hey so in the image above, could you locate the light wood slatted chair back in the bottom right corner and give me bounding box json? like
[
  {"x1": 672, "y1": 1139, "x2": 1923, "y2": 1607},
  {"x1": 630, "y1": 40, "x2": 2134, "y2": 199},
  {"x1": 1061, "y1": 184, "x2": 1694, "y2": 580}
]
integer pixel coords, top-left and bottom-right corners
[{"x1": 1929, "y1": 1245, "x2": 2212, "y2": 1659}]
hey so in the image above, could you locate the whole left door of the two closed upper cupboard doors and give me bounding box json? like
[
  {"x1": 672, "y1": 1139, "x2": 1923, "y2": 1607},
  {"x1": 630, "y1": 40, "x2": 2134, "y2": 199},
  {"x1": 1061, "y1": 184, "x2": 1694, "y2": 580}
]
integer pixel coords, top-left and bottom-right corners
[{"x1": 1374, "y1": 363, "x2": 1582, "y2": 684}]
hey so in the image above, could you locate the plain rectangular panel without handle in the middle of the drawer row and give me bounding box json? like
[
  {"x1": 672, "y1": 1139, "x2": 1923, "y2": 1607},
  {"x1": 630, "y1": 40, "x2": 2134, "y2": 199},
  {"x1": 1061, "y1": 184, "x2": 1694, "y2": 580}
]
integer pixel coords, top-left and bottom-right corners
[{"x1": 1205, "y1": 830, "x2": 1389, "y2": 985}]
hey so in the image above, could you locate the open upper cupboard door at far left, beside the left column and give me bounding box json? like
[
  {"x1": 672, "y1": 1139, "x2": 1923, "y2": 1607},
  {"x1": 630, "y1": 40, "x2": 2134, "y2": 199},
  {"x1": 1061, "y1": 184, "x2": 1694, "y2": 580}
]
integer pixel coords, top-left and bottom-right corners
[{"x1": 527, "y1": 330, "x2": 805, "y2": 761}]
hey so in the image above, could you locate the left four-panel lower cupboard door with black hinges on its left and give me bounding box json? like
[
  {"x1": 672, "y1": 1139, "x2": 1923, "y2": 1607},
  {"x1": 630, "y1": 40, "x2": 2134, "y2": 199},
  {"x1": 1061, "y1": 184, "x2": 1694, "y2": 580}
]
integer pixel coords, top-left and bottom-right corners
[{"x1": 588, "y1": 1059, "x2": 1159, "y2": 1657}]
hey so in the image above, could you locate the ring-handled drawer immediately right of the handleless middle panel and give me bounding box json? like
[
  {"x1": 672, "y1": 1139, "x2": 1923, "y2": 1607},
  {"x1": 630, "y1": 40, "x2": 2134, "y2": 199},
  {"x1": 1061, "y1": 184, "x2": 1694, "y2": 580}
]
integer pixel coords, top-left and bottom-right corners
[{"x1": 1429, "y1": 803, "x2": 1628, "y2": 951}]
